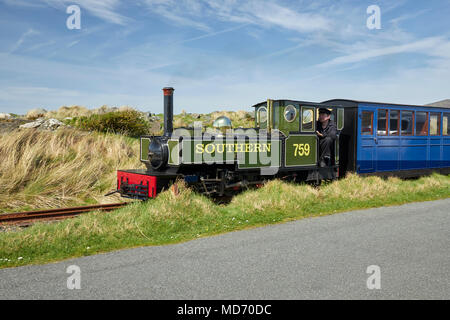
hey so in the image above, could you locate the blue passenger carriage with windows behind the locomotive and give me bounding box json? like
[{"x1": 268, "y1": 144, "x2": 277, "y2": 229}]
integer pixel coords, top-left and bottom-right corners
[{"x1": 324, "y1": 99, "x2": 450, "y2": 177}]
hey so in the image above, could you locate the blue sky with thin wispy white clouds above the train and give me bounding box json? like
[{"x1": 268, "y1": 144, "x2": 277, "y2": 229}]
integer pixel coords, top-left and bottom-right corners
[{"x1": 0, "y1": 0, "x2": 450, "y2": 113}]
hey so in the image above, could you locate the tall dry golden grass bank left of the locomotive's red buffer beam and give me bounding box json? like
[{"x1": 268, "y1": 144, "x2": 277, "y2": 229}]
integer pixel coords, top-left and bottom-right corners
[{"x1": 0, "y1": 129, "x2": 141, "y2": 212}]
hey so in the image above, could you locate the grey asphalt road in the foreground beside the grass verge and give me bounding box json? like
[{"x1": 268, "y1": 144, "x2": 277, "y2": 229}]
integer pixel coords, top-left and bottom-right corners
[{"x1": 0, "y1": 199, "x2": 450, "y2": 299}]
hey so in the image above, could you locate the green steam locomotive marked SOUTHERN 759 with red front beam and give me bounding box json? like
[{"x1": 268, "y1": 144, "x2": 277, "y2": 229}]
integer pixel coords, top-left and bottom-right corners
[{"x1": 117, "y1": 88, "x2": 344, "y2": 199}]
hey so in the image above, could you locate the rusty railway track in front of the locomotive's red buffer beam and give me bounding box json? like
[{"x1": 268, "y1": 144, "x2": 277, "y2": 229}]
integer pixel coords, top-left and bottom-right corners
[{"x1": 0, "y1": 202, "x2": 127, "y2": 227}]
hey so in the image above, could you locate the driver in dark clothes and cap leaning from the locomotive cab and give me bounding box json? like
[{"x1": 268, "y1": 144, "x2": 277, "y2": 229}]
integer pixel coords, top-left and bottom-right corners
[{"x1": 316, "y1": 108, "x2": 336, "y2": 168}]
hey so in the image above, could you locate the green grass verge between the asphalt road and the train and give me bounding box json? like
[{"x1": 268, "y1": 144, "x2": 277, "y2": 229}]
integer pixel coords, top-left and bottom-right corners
[{"x1": 0, "y1": 174, "x2": 450, "y2": 268}]
